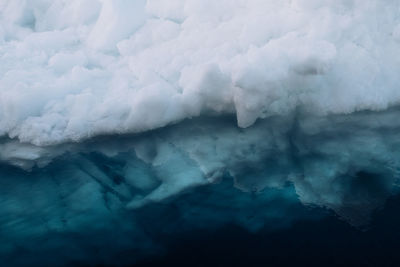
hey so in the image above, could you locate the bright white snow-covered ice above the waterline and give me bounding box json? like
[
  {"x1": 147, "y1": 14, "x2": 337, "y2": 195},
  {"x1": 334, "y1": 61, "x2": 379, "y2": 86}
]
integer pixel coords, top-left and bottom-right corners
[{"x1": 0, "y1": 0, "x2": 400, "y2": 146}]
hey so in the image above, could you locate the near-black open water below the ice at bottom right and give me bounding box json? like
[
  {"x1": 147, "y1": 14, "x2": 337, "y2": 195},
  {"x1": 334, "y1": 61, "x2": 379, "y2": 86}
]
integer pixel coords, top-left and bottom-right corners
[{"x1": 134, "y1": 194, "x2": 400, "y2": 266}]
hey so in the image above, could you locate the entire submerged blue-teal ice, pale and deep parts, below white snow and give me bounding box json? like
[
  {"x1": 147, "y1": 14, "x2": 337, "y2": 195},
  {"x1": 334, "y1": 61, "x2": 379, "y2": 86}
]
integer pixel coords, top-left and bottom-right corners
[{"x1": 0, "y1": 109, "x2": 400, "y2": 266}]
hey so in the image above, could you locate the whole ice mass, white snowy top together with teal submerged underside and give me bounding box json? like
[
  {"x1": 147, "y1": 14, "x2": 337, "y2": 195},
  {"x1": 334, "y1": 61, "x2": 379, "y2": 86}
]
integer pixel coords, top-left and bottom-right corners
[{"x1": 0, "y1": 0, "x2": 400, "y2": 266}]
